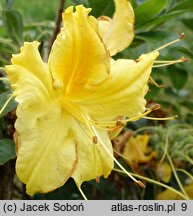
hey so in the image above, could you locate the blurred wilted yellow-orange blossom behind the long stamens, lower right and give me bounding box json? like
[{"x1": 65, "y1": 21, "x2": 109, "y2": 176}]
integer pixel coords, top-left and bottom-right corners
[{"x1": 123, "y1": 134, "x2": 156, "y2": 166}]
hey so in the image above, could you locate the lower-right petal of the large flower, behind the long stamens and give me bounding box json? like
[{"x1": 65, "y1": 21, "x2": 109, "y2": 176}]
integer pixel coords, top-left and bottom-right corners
[{"x1": 72, "y1": 124, "x2": 113, "y2": 186}]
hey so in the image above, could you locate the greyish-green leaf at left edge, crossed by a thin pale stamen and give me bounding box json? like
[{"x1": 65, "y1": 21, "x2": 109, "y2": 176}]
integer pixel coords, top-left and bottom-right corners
[{"x1": 0, "y1": 91, "x2": 17, "y2": 117}]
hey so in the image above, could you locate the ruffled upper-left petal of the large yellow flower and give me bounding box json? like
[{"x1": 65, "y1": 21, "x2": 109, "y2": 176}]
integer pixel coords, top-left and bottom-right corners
[{"x1": 6, "y1": 41, "x2": 52, "y2": 106}]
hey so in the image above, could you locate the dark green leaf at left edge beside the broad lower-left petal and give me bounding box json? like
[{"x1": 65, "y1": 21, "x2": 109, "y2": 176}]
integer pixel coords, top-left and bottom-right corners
[{"x1": 0, "y1": 139, "x2": 16, "y2": 165}]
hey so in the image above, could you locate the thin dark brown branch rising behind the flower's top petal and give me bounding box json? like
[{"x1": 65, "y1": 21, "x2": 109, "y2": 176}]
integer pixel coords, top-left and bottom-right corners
[{"x1": 48, "y1": 0, "x2": 65, "y2": 53}]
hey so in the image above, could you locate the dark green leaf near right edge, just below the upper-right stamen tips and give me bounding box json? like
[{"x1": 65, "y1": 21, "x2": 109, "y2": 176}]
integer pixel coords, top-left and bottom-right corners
[{"x1": 168, "y1": 66, "x2": 188, "y2": 90}]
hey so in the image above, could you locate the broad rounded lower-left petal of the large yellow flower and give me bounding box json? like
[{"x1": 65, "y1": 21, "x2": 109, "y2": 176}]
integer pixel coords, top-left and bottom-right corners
[{"x1": 15, "y1": 106, "x2": 78, "y2": 195}]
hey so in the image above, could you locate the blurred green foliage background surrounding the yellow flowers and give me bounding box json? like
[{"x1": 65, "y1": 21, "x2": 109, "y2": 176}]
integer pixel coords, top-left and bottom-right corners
[{"x1": 0, "y1": 0, "x2": 193, "y2": 199}]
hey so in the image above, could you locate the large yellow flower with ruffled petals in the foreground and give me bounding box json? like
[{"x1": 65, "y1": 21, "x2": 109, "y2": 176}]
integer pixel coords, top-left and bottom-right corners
[{"x1": 6, "y1": 0, "x2": 158, "y2": 195}]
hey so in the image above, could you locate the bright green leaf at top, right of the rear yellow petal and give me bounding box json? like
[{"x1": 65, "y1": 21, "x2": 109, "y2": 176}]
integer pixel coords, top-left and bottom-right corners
[{"x1": 135, "y1": 0, "x2": 168, "y2": 26}]
